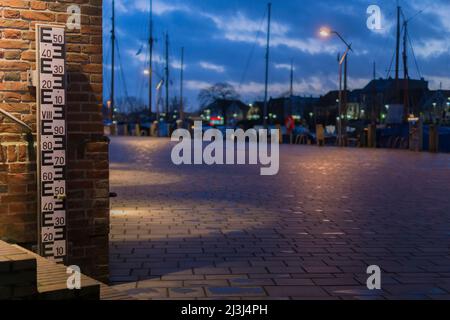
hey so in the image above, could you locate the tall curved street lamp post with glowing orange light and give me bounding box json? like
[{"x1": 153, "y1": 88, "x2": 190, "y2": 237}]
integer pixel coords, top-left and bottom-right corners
[{"x1": 320, "y1": 28, "x2": 353, "y2": 146}]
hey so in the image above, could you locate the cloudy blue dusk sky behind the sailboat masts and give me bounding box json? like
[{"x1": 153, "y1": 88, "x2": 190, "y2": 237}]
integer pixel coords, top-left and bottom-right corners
[{"x1": 103, "y1": 0, "x2": 450, "y2": 110}]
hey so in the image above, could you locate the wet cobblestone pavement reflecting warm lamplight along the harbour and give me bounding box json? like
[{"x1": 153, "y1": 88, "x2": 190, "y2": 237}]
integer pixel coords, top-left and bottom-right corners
[{"x1": 110, "y1": 138, "x2": 450, "y2": 299}]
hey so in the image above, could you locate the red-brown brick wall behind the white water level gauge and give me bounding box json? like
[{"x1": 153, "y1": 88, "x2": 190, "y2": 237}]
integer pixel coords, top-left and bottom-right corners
[{"x1": 0, "y1": 0, "x2": 109, "y2": 280}]
